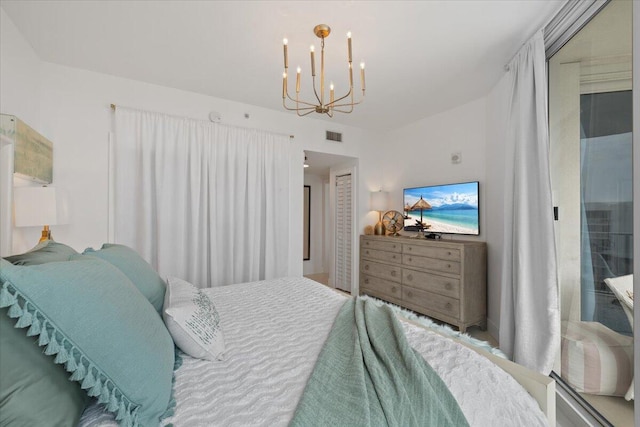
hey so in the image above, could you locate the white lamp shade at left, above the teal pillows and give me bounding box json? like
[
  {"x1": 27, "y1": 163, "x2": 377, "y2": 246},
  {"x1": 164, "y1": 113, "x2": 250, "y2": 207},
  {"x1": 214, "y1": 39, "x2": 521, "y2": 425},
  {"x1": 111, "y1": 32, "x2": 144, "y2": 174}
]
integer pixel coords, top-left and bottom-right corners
[{"x1": 13, "y1": 187, "x2": 58, "y2": 227}]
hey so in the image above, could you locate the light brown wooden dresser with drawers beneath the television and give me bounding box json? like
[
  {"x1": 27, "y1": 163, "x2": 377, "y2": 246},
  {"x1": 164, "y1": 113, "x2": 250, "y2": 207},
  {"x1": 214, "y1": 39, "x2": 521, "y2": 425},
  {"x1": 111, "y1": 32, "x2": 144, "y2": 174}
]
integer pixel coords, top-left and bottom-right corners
[{"x1": 360, "y1": 236, "x2": 487, "y2": 332}]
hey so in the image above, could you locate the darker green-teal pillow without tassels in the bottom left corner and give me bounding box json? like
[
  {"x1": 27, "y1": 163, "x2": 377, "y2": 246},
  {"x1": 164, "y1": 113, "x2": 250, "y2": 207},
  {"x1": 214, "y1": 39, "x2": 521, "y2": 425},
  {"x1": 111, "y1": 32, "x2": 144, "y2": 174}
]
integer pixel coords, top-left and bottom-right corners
[{"x1": 0, "y1": 309, "x2": 89, "y2": 427}]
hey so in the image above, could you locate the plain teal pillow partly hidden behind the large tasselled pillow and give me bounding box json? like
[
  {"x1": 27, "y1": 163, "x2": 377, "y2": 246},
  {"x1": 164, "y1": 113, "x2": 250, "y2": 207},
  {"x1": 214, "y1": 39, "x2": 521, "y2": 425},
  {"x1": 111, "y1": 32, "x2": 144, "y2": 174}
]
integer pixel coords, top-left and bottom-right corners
[{"x1": 83, "y1": 243, "x2": 167, "y2": 313}]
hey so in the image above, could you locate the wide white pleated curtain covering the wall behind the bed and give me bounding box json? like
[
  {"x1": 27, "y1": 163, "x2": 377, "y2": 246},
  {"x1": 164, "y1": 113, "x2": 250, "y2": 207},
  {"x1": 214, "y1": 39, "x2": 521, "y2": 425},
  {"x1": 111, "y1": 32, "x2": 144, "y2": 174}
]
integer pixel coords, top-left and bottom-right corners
[{"x1": 113, "y1": 107, "x2": 291, "y2": 287}]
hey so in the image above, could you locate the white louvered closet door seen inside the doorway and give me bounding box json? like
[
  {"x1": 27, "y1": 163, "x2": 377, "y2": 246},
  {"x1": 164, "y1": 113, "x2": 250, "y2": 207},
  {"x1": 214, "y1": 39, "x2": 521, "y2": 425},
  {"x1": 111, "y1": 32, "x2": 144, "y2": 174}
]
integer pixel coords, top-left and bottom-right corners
[{"x1": 334, "y1": 174, "x2": 353, "y2": 292}]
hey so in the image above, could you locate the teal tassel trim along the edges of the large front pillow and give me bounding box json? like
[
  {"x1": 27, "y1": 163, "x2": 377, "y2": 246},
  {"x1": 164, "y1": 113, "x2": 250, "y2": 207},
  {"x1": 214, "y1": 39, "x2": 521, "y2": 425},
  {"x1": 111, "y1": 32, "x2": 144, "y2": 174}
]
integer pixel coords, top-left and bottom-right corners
[{"x1": 0, "y1": 281, "x2": 142, "y2": 427}]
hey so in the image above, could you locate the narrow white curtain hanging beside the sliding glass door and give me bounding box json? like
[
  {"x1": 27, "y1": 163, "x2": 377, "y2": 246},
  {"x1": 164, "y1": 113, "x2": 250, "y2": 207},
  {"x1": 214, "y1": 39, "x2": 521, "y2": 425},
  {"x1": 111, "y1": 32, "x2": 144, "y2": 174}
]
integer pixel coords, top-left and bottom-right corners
[{"x1": 500, "y1": 31, "x2": 560, "y2": 374}]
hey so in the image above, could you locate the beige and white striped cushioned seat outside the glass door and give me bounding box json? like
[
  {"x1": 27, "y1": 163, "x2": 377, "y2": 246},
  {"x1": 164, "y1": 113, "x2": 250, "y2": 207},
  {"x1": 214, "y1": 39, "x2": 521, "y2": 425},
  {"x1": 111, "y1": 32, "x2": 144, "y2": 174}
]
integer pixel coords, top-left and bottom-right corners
[{"x1": 561, "y1": 320, "x2": 633, "y2": 396}]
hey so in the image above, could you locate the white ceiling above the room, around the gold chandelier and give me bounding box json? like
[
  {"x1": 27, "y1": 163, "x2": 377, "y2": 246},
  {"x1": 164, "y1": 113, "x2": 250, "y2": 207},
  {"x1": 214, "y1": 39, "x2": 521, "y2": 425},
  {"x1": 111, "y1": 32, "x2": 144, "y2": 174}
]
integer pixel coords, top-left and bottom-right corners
[{"x1": 0, "y1": 0, "x2": 564, "y2": 130}]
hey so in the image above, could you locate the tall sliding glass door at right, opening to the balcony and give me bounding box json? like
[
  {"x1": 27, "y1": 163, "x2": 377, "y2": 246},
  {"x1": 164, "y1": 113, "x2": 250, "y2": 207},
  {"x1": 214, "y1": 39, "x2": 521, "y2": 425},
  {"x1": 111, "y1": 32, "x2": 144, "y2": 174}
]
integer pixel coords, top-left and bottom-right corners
[{"x1": 549, "y1": 0, "x2": 633, "y2": 425}]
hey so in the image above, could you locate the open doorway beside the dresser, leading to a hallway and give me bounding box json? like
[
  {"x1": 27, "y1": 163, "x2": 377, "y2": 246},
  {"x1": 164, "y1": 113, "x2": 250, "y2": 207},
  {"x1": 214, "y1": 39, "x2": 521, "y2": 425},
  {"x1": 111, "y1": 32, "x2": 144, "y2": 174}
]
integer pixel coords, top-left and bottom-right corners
[{"x1": 303, "y1": 151, "x2": 358, "y2": 292}]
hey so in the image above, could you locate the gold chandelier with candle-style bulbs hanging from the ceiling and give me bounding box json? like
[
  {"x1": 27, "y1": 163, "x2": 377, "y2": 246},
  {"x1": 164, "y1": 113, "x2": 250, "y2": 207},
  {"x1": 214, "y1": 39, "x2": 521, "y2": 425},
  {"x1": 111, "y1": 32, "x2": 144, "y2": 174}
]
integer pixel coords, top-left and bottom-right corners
[{"x1": 282, "y1": 24, "x2": 365, "y2": 117}]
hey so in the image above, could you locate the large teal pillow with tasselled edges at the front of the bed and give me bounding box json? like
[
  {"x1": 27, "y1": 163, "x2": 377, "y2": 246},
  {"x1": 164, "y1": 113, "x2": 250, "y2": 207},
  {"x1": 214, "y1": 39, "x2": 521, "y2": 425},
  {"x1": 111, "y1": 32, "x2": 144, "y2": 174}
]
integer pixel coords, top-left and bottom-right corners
[{"x1": 0, "y1": 255, "x2": 175, "y2": 426}]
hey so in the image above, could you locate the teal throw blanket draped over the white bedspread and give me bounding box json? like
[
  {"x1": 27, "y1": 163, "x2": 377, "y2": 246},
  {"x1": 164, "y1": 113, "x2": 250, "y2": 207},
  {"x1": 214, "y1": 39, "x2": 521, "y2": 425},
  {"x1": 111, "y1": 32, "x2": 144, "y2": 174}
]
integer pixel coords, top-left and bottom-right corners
[{"x1": 290, "y1": 298, "x2": 468, "y2": 427}]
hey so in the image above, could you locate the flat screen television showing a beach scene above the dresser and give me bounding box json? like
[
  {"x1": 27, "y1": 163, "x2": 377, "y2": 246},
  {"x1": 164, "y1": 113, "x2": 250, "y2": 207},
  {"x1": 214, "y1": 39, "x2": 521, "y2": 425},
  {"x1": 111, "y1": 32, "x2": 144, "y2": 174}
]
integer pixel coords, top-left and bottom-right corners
[{"x1": 403, "y1": 181, "x2": 480, "y2": 236}]
